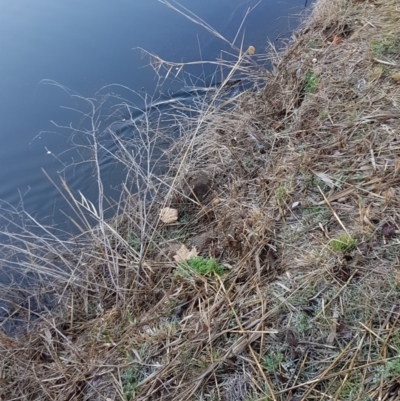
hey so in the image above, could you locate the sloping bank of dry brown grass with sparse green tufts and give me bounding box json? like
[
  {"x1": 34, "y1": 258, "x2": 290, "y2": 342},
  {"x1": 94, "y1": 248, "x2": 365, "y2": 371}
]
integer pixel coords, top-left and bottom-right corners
[{"x1": 0, "y1": 0, "x2": 400, "y2": 401}]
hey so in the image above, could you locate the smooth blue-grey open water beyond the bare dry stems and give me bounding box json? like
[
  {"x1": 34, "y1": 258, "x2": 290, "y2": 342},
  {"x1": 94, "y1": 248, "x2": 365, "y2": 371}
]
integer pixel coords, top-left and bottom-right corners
[{"x1": 0, "y1": 0, "x2": 310, "y2": 234}]
